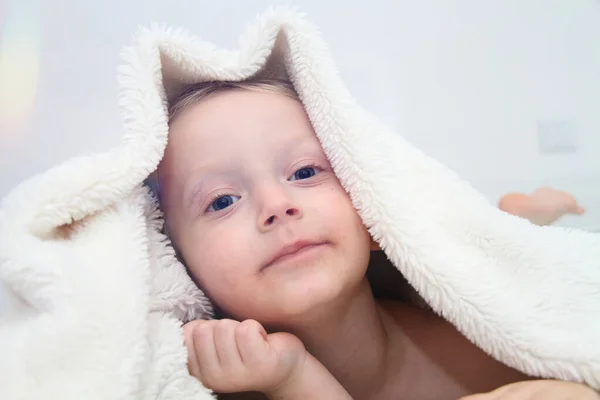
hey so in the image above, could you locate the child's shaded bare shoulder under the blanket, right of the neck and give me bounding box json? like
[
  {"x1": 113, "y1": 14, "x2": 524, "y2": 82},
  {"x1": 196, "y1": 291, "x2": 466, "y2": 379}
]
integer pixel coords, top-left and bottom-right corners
[{"x1": 379, "y1": 301, "x2": 527, "y2": 399}]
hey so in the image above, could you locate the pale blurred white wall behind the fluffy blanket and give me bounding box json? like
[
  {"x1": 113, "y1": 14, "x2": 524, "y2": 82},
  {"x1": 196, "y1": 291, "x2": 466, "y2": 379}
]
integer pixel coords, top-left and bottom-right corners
[{"x1": 0, "y1": 0, "x2": 600, "y2": 229}]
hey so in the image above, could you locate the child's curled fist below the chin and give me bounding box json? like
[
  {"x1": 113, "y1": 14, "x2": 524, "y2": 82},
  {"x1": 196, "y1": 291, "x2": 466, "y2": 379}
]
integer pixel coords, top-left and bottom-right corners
[{"x1": 183, "y1": 319, "x2": 308, "y2": 393}]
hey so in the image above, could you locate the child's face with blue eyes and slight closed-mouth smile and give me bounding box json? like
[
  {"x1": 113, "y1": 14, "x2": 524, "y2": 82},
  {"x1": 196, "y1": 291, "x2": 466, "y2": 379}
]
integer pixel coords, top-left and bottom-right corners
[{"x1": 159, "y1": 90, "x2": 371, "y2": 325}]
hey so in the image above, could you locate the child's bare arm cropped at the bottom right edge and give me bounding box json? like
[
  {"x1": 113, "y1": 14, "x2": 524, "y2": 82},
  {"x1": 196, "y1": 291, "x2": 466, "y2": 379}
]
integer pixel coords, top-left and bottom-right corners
[{"x1": 461, "y1": 380, "x2": 600, "y2": 400}]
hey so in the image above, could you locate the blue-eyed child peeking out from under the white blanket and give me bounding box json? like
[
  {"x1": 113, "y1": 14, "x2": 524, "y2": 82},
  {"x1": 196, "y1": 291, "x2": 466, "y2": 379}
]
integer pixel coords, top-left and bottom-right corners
[{"x1": 157, "y1": 80, "x2": 598, "y2": 400}]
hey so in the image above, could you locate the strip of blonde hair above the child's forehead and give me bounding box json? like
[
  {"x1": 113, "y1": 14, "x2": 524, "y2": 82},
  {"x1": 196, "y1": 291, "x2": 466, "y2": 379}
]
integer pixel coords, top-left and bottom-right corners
[{"x1": 169, "y1": 79, "x2": 299, "y2": 124}]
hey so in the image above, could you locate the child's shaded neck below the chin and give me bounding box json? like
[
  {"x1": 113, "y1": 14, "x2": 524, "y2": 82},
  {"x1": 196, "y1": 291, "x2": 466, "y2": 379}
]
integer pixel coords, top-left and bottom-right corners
[{"x1": 274, "y1": 279, "x2": 389, "y2": 398}]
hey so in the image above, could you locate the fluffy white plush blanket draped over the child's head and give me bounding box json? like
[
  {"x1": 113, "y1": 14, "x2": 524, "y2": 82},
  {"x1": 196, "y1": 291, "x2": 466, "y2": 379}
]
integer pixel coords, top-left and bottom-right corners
[{"x1": 0, "y1": 9, "x2": 600, "y2": 399}]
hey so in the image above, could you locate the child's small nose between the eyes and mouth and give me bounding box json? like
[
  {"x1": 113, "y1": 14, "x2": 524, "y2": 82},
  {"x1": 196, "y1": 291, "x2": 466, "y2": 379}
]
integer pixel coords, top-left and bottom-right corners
[{"x1": 258, "y1": 188, "x2": 302, "y2": 232}]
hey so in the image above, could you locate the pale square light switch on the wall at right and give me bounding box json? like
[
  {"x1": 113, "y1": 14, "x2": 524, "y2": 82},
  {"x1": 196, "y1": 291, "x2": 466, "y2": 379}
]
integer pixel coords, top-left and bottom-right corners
[{"x1": 537, "y1": 120, "x2": 578, "y2": 154}]
